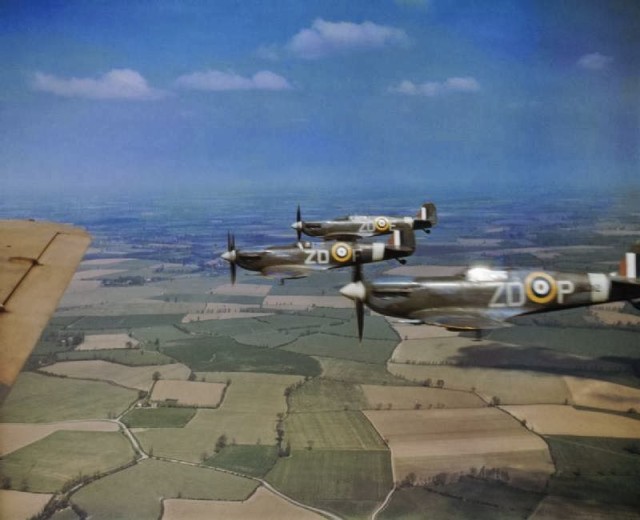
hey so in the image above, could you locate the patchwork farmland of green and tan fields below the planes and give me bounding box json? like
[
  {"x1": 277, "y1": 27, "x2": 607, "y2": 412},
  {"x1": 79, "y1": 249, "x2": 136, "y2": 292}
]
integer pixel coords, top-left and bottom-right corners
[{"x1": 0, "y1": 191, "x2": 640, "y2": 520}]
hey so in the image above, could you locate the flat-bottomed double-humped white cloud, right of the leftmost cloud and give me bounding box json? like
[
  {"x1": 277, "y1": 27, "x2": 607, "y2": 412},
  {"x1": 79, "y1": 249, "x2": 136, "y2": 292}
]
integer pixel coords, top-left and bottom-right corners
[{"x1": 176, "y1": 70, "x2": 292, "y2": 91}]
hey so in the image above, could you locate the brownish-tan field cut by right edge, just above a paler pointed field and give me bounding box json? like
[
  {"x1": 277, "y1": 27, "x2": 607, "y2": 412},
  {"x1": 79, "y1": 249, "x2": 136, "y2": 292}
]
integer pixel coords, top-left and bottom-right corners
[{"x1": 563, "y1": 376, "x2": 640, "y2": 412}]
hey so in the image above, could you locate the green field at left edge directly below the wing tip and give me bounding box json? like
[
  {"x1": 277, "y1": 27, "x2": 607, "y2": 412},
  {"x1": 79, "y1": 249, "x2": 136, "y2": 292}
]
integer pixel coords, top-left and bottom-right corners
[{"x1": 0, "y1": 372, "x2": 138, "y2": 422}]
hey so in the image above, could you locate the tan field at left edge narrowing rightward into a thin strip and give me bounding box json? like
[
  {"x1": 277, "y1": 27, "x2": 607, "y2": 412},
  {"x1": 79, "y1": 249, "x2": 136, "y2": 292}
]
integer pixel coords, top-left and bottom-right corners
[{"x1": 0, "y1": 421, "x2": 119, "y2": 456}]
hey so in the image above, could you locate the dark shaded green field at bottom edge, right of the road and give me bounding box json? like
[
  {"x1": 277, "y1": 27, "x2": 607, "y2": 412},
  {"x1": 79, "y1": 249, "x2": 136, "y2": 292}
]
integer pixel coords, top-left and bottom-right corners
[{"x1": 378, "y1": 478, "x2": 542, "y2": 520}]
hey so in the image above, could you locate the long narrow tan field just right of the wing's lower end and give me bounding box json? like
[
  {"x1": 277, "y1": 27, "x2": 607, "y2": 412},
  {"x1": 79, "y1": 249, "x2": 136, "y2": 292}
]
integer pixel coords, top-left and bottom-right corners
[{"x1": 42, "y1": 360, "x2": 191, "y2": 390}]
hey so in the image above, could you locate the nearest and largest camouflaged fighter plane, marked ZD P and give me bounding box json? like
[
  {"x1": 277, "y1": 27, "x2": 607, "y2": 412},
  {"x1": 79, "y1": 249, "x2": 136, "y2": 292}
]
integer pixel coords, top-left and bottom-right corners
[{"x1": 340, "y1": 244, "x2": 640, "y2": 338}]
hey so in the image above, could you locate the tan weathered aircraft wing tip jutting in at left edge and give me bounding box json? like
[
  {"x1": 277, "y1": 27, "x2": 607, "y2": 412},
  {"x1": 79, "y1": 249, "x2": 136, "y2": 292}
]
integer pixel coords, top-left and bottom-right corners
[{"x1": 0, "y1": 220, "x2": 91, "y2": 402}]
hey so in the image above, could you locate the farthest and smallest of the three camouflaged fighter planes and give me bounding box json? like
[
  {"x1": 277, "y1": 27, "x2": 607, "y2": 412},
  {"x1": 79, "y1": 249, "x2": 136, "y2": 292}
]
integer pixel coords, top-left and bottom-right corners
[{"x1": 291, "y1": 202, "x2": 438, "y2": 241}]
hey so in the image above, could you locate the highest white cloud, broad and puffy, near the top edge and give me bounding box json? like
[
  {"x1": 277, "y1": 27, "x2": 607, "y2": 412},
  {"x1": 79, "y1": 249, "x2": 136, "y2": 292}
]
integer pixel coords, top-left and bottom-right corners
[{"x1": 287, "y1": 18, "x2": 409, "y2": 59}]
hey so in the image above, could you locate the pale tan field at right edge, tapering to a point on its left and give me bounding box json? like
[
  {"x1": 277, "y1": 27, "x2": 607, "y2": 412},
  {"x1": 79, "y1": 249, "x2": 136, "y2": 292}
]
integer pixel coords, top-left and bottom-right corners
[{"x1": 503, "y1": 404, "x2": 640, "y2": 439}]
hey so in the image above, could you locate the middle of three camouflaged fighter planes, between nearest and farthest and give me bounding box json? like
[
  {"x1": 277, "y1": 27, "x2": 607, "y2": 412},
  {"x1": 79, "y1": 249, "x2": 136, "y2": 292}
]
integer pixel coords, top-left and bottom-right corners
[{"x1": 222, "y1": 229, "x2": 416, "y2": 283}]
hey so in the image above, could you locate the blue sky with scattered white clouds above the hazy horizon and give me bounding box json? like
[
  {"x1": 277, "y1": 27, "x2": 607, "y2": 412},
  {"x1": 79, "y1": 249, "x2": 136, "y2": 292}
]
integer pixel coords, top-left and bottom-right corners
[{"x1": 0, "y1": 0, "x2": 640, "y2": 196}]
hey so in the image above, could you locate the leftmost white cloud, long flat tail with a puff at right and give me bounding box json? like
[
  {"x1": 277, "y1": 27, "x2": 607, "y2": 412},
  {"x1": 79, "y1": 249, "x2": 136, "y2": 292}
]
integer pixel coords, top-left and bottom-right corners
[{"x1": 32, "y1": 69, "x2": 165, "y2": 99}]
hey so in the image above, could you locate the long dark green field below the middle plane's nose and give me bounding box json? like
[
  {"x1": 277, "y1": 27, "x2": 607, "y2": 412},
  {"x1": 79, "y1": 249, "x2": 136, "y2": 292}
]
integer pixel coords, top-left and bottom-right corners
[{"x1": 162, "y1": 336, "x2": 320, "y2": 376}]
